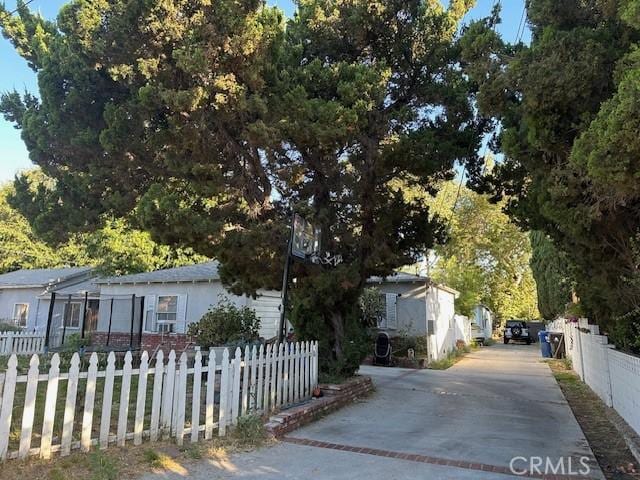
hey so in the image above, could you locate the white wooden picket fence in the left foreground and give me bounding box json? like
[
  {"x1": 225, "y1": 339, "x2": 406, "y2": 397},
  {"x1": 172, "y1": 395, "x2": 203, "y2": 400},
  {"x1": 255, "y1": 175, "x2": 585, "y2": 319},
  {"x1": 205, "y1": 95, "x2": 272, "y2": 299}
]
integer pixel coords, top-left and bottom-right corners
[{"x1": 0, "y1": 342, "x2": 318, "y2": 460}]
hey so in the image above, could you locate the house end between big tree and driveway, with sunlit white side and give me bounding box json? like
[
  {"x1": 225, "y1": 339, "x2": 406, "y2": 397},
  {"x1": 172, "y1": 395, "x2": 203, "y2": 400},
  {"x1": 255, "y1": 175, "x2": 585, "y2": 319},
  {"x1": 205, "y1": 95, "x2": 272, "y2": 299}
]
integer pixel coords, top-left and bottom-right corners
[{"x1": 367, "y1": 272, "x2": 459, "y2": 360}]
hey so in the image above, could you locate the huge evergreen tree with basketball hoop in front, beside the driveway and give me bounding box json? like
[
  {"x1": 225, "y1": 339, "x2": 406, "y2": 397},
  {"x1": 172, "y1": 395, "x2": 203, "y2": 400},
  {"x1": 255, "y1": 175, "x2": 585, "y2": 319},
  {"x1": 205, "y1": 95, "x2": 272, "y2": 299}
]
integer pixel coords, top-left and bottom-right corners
[{"x1": 2, "y1": 0, "x2": 483, "y2": 373}]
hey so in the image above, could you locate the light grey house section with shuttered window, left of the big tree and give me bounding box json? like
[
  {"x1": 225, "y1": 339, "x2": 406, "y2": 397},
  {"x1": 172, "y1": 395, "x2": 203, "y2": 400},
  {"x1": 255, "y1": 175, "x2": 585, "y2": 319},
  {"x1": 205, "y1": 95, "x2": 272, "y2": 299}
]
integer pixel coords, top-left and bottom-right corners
[{"x1": 92, "y1": 261, "x2": 281, "y2": 351}]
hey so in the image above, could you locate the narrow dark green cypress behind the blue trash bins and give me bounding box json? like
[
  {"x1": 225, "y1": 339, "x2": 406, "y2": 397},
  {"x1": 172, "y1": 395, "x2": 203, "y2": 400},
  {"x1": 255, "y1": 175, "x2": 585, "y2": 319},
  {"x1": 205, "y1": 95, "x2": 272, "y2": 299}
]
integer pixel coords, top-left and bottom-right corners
[{"x1": 529, "y1": 231, "x2": 573, "y2": 320}]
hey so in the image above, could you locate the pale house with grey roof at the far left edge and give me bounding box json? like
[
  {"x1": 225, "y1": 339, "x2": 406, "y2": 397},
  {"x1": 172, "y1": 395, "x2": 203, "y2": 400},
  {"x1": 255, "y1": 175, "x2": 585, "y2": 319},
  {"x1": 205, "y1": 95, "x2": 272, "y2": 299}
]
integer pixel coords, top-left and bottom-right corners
[{"x1": 0, "y1": 267, "x2": 93, "y2": 331}]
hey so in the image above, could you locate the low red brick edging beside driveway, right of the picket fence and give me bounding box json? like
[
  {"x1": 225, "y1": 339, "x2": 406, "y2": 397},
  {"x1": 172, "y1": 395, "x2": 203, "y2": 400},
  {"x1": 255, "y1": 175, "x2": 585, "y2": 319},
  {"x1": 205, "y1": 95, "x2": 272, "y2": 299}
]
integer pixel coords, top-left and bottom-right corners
[{"x1": 265, "y1": 377, "x2": 373, "y2": 438}]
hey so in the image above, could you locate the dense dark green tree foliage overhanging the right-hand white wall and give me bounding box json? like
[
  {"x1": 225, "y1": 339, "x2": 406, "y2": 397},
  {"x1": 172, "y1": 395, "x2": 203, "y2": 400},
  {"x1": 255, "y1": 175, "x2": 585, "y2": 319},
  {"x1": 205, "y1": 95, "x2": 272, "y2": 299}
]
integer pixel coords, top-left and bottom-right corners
[{"x1": 461, "y1": 0, "x2": 640, "y2": 343}]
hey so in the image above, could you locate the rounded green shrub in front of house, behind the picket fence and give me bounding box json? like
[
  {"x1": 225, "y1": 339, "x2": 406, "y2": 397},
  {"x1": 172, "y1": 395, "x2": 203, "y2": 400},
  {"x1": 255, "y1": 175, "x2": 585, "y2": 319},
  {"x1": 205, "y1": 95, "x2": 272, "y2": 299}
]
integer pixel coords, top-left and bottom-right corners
[{"x1": 187, "y1": 296, "x2": 260, "y2": 348}]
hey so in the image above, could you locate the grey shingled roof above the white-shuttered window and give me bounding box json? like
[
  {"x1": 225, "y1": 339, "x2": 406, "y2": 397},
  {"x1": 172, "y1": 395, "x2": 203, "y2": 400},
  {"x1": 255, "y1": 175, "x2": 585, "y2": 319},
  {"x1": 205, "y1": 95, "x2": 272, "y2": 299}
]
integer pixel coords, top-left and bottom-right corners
[{"x1": 96, "y1": 260, "x2": 220, "y2": 285}]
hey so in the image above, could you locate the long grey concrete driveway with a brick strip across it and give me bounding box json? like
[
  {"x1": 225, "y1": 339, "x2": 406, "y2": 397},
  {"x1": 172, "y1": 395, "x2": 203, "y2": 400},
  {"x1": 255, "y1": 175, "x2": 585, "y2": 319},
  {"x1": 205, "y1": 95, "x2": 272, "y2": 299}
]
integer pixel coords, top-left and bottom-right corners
[{"x1": 145, "y1": 344, "x2": 604, "y2": 480}]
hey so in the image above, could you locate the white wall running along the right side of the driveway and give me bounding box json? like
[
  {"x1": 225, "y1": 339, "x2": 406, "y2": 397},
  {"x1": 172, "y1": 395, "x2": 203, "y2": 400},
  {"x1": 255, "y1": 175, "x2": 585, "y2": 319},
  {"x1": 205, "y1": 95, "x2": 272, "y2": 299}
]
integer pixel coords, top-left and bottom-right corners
[{"x1": 547, "y1": 318, "x2": 640, "y2": 435}]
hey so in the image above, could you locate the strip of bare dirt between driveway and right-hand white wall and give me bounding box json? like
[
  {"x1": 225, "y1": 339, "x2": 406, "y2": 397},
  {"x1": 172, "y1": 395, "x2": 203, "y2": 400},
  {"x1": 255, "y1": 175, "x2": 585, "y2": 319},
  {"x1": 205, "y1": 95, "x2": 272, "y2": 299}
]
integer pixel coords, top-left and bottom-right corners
[{"x1": 547, "y1": 360, "x2": 640, "y2": 480}]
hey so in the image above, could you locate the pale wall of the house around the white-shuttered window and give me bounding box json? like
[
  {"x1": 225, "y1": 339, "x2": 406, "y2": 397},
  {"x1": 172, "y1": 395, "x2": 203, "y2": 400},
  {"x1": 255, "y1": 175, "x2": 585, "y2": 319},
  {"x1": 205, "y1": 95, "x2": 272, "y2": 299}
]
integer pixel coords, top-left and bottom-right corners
[{"x1": 98, "y1": 281, "x2": 280, "y2": 338}]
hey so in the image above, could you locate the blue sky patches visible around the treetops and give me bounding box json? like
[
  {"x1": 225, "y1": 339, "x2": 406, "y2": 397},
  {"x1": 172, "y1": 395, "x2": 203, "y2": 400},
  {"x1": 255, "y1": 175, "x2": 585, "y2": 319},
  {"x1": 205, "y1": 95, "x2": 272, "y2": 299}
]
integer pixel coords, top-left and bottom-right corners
[{"x1": 0, "y1": 0, "x2": 529, "y2": 182}]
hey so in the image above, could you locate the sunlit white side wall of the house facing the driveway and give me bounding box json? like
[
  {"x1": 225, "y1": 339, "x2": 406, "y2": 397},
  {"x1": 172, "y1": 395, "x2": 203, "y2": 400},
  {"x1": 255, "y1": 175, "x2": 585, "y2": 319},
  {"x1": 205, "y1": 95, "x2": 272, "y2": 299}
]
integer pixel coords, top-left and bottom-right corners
[{"x1": 427, "y1": 286, "x2": 456, "y2": 359}]
